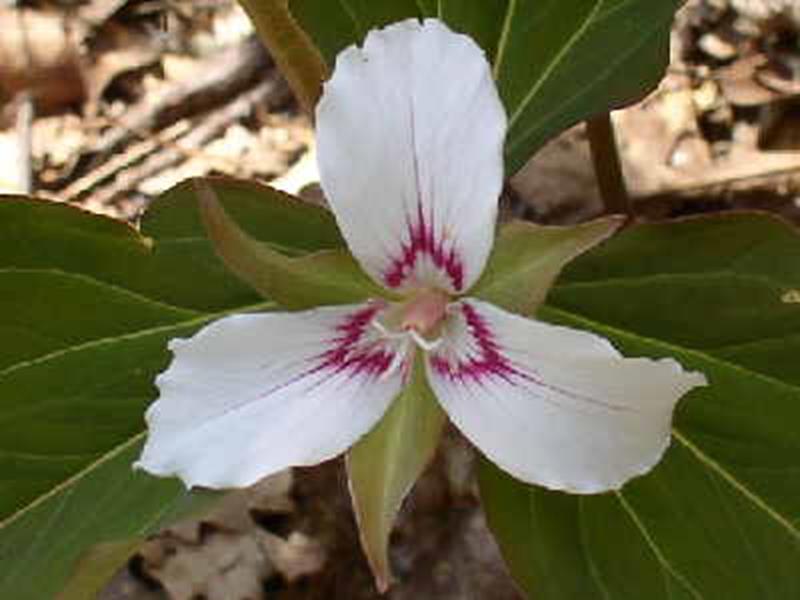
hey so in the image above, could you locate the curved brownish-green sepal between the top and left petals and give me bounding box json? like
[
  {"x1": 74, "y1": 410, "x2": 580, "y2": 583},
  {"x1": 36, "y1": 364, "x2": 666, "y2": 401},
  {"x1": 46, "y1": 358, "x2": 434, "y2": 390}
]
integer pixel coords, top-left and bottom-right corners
[{"x1": 196, "y1": 181, "x2": 383, "y2": 309}]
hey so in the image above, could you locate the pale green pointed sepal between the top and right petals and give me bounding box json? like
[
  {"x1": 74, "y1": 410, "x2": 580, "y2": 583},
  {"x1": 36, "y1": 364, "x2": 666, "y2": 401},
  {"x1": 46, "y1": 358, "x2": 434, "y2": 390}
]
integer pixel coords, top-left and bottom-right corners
[{"x1": 469, "y1": 217, "x2": 622, "y2": 314}]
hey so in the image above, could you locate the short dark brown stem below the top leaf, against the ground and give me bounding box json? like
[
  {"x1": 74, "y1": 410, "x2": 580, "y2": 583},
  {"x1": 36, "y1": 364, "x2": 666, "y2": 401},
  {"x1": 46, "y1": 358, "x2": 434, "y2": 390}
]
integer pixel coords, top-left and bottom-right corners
[{"x1": 586, "y1": 113, "x2": 633, "y2": 217}]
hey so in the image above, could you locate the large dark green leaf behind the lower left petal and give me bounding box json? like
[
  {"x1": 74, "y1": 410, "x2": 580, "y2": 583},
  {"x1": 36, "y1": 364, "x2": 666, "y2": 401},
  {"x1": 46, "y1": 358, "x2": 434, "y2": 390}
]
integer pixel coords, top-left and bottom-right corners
[{"x1": 0, "y1": 180, "x2": 343, "y2": 600}]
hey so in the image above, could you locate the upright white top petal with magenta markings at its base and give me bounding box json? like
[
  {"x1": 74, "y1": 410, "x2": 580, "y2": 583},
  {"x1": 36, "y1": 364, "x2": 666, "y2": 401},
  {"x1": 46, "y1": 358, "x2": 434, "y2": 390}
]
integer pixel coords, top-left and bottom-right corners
[{"x1": 317, "y1": 19, "x2": 506, "y2": 292}]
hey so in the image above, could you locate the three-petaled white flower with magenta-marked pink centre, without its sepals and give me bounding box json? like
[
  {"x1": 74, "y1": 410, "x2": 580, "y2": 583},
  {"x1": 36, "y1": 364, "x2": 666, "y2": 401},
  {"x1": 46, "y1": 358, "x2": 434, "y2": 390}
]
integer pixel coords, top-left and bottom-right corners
[{"x1": 138, "y1": 20, "x2": 705, "y2": 493}]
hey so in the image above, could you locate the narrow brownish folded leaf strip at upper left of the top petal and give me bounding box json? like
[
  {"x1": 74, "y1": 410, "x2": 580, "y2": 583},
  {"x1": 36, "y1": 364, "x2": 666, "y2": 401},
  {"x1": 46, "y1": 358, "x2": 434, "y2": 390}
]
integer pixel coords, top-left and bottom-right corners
[{"x1": 240, "y1": 0, "x2": 326, "y2": 115}]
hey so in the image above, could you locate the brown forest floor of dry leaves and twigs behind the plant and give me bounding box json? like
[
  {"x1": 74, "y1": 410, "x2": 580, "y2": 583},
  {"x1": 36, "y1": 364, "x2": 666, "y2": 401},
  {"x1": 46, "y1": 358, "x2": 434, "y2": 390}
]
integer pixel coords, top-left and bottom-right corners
[{"x1": 6, "y1": 0, "x2": 800, "y2": 600}]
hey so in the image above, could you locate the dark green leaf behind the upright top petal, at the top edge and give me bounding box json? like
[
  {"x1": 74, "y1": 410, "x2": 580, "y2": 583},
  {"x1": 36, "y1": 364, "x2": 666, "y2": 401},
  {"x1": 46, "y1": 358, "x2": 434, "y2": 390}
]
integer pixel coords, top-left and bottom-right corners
[{"x1": 289, "y1": 0, "x2": 681, "y2": 174}]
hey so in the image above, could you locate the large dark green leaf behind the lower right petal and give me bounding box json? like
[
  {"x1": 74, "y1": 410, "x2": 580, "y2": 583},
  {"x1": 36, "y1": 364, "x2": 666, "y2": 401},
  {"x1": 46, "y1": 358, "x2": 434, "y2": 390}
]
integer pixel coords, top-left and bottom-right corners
[{"x1": 481, "y1": 215, "x2": 800, "y2": 600}]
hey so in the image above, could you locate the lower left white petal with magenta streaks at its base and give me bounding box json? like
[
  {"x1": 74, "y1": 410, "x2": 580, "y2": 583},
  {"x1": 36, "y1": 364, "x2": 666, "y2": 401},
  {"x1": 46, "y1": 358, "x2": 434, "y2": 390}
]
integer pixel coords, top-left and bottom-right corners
[{"x1": 137, "y1": 303, "x2": 406, "y2": 488}]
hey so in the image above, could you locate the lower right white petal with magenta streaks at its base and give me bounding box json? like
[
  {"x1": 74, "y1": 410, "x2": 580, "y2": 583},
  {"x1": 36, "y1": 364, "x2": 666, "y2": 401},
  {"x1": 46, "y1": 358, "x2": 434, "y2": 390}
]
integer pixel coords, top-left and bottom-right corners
[{"x1": 428, "y1": 300, "x2": 706, "y2": 493}]
